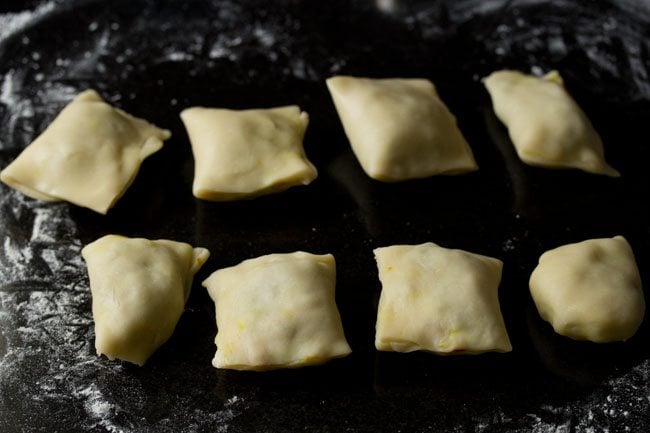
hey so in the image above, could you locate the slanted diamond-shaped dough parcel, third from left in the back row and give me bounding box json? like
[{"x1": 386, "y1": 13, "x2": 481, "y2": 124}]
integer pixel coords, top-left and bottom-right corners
[{"x1": 327, "y1": 76, "x2": 478, "y2": 182}]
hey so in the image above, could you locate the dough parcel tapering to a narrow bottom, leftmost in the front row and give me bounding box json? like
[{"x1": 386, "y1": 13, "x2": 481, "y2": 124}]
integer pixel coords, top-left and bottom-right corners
[{"x1": 82, "y1": 235, "x2": 210, "y2": 365}]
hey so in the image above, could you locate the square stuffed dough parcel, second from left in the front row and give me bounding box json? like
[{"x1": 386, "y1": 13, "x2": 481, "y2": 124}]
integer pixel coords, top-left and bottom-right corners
[{"x1": 203, "y1": 251, "x2": 350, "y2": 371}]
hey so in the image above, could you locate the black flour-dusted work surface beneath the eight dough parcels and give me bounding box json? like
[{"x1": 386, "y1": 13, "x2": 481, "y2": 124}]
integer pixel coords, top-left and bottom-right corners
[{"x1": 0, "y1": 0, "x2": 650, "y2": 433}]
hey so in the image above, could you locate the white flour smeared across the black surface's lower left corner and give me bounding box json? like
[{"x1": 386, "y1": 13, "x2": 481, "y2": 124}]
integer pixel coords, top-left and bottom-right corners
[{"x1": 0, "y1": 184, "x2": 246, "y2": 433}]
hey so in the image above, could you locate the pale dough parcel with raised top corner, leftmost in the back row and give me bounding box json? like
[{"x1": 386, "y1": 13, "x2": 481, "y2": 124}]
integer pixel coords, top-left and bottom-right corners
[{"x1": 0, "y1": 90, "x2": 171, "y2": 214}]
